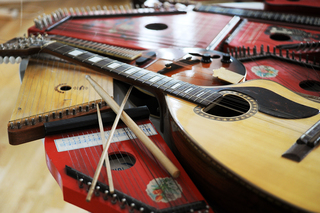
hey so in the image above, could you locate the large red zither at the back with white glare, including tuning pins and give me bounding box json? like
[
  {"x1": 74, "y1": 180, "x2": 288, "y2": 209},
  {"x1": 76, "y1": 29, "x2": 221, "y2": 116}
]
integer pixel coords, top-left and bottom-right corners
[{"x1": 28, "y1": 5, "x2": 238, "y2": 49}]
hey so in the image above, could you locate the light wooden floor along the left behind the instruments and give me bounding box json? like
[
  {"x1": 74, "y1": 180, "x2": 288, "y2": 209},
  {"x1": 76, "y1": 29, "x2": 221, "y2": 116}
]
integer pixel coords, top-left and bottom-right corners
[{"x1": 0, "y1": 0, "x2": 128, "y2": 213}]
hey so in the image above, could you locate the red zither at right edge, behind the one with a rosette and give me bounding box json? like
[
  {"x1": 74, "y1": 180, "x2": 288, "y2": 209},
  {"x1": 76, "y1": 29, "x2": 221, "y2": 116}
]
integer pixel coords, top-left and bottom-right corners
[{"x1": 223, "y1": 21, "x2": 320, "y2": 58}]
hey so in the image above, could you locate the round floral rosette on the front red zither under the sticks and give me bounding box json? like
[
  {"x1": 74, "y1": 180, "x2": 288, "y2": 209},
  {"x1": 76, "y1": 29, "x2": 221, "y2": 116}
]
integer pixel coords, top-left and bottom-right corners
[{"x1": 146, "y1": 177, "x2": 182, "y2": 203}]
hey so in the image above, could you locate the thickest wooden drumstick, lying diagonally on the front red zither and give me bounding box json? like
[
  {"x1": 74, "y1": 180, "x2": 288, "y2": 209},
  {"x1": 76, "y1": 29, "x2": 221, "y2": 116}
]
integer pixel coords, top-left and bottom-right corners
[{"x1": 86, "y1": 75, "x2": 180, "y2": 178}]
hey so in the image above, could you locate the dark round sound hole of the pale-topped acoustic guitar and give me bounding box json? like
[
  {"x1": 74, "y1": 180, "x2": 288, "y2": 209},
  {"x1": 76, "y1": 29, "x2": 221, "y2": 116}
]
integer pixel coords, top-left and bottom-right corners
[{"x1": 203, "y1": 95, "x2": 250, "y2": 117}]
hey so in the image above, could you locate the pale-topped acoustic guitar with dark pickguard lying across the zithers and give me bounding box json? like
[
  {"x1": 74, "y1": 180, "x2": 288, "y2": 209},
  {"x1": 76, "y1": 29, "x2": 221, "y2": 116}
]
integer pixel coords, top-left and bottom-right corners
[{"x1": 1, "y1": 35, "x2": 320, "y2": 212}]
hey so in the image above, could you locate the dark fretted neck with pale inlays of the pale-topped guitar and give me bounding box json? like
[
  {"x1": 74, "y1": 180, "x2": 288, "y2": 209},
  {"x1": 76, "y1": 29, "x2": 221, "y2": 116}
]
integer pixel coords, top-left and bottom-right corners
[{"x1": 42, "y1": 42, "x2": 221, "y2": 106}]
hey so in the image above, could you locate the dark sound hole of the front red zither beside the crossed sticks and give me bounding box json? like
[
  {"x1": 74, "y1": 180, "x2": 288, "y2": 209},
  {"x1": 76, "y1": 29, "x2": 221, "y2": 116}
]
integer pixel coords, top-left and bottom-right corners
[{"x1": 109, "y1": 153, "x2": 136, "y2": 171}]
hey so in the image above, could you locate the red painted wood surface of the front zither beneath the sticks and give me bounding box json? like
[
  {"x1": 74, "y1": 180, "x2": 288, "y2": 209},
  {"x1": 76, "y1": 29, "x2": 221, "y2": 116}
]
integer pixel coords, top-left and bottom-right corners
[{"x1": 45, "y1": 120, "x2": 212, "y2": 213}]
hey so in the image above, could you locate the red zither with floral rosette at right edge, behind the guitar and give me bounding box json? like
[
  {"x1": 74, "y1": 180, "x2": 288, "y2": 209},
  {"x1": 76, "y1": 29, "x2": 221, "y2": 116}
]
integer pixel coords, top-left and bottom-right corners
[{"x1": 230, "y1": 47, "x2": 320, "y2": 98}]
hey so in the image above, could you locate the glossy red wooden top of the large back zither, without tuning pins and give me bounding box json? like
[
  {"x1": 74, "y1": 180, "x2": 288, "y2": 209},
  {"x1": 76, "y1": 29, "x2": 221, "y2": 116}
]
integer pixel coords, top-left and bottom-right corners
[{"x1": 28, "y1": 11, "x2": 232, "y2": 49}]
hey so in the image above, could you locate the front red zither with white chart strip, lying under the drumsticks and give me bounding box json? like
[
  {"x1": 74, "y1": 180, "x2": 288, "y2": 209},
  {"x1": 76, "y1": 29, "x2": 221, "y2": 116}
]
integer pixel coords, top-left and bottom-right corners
[{"x1": 44, "y1": 115, "x2": 212, "y2": 213}]
